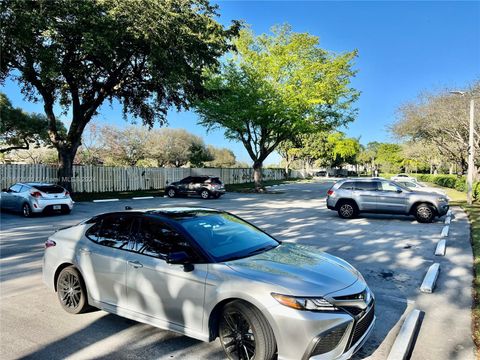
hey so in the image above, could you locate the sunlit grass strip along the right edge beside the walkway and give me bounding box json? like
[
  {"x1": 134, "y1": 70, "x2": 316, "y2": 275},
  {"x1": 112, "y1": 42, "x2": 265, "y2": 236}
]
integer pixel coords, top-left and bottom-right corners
[{"x1": 429, "y1": 184, "x2": 480, "y2": 350}]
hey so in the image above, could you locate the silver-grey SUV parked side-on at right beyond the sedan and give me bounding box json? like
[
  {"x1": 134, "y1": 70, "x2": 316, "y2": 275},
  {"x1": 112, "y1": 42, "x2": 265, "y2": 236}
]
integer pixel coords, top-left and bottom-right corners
[{"x1": 327, "y1": 178, "x2": 449, "y2": 223}]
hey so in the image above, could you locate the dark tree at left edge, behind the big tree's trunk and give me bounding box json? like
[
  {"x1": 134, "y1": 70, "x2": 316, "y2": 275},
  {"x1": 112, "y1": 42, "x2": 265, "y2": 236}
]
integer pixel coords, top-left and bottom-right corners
[{"x1": 0, "y1": 93, "x2": 65, "y2": 153}]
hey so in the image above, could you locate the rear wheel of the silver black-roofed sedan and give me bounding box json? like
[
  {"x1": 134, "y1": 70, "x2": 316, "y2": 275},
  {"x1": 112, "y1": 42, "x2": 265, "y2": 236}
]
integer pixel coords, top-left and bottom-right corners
[{"x1": 57, "y1": 266, "x2": 89, "y2": 314}]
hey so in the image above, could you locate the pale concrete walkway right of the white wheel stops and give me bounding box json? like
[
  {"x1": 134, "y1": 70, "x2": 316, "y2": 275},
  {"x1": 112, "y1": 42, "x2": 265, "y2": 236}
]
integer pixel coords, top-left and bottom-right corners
[{"x1": 411, "y1": 207, "x2": 475, "y2": 360}]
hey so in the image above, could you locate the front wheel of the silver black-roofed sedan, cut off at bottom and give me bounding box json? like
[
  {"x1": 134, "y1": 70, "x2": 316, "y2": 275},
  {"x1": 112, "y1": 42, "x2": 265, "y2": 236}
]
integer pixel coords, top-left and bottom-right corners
[{"x1": 219, "y1": 301, "x2": 277, "y2": 360}]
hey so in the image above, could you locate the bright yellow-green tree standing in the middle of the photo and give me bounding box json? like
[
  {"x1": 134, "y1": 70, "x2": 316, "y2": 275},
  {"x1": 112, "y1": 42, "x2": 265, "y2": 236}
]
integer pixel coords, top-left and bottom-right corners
[{"x1": 195, "y1": 26, "x2": 358, "y2": 191}]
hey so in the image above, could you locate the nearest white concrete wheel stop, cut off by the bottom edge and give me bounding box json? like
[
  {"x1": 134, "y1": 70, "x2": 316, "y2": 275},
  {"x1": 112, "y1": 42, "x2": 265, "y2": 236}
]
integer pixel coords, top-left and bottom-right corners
[{"x1": 387, "y1": 309, "x2": 423, "y2": 360}]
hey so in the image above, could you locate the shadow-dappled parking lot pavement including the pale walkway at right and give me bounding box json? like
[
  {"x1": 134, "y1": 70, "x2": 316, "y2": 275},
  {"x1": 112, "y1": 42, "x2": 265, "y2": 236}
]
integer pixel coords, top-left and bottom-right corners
[{"x1": 0, "y1": 181, "x2": 474, "y2": 360}]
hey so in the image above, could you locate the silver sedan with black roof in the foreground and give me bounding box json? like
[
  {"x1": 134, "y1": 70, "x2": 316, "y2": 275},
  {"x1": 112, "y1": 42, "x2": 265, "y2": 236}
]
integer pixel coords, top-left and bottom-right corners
[{"x1": 43, "y1": 208, "x2": 375, "y2": 360}]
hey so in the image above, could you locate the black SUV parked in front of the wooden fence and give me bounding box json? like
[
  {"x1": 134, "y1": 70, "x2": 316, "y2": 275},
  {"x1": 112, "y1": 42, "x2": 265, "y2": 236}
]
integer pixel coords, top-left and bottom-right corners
[{"x1": 165, "y1": 176, "x2": 225, "y2": 199}]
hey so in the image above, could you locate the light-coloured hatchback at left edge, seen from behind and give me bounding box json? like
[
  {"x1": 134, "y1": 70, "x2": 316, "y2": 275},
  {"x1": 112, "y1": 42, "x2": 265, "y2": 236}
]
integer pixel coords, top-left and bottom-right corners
[{"x1": 0, "y1": 183, "x2": 73, "y2": 217}]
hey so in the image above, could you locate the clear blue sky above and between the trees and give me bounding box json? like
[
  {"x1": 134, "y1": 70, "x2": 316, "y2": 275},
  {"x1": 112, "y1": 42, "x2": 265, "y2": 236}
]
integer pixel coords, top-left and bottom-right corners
[{"x1": 2, "y1": 1, "x2": 480, "y2": 164}]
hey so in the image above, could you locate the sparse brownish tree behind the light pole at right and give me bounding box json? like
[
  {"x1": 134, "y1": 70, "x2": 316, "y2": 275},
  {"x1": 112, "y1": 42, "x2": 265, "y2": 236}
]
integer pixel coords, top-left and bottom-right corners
[{"x1": 391, "y1": 81, "x2": 480, "y2": 172}]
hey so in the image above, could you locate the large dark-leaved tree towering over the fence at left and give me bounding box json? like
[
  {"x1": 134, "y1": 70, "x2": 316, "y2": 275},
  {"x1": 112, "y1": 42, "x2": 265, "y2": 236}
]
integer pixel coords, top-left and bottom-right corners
[{"x1": 0, "y1": 0, "x2": 239, "y2": 188}]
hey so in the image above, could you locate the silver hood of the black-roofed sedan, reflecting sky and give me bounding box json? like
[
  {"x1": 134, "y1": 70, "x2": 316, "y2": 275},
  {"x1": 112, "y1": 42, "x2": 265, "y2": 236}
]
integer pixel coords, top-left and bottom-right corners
[{"x1": 226, "y1": 243, "x2": 359, "y2": 296}]
